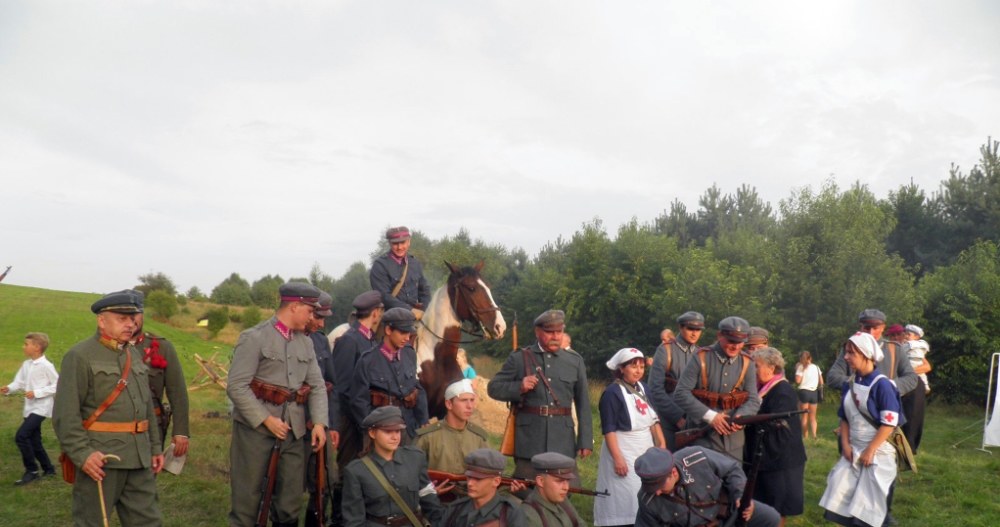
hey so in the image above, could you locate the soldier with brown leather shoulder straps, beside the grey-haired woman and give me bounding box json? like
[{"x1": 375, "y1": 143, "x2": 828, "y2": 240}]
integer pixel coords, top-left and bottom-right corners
[{"x1": 674, "y1": 317, "x2": 760, "y2": 461}]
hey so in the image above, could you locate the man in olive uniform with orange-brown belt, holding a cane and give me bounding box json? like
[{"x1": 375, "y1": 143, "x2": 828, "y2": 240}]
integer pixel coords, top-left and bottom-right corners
[{"x1": 52, "y1": 290, "x2": 163, "y2": 527}]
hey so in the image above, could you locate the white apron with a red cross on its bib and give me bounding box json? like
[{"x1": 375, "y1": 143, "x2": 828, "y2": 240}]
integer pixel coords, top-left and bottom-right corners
[{"x1": 594, "y1": 384, "x2": 659, "y2": 526}]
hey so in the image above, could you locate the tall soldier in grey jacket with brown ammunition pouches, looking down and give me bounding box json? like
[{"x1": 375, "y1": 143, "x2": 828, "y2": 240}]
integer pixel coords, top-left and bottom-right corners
[{"x1": 226, "y1": 283, "x2": 328, "y2": 527}]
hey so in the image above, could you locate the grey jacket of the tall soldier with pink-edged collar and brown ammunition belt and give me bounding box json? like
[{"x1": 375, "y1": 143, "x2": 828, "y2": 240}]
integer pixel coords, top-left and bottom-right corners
[{"x1": 226, "y1": 317, "x2": 329, "y2": 439}]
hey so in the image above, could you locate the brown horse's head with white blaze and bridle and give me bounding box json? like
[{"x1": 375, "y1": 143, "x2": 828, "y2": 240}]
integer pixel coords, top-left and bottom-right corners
[{"x1": 445, "y1": 260, "x2": 507, "y2": 339}]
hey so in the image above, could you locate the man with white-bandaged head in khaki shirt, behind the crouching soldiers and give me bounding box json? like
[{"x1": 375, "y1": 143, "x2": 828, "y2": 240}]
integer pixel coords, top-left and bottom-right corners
[{"x1": 414, "y1": 379, "x2": 489, "y2": 474}]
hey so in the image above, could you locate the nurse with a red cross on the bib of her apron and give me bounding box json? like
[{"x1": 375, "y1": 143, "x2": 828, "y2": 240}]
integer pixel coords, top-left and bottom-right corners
[{"x1": 594, "y1": 348, "x2": 667, "y2": 526}]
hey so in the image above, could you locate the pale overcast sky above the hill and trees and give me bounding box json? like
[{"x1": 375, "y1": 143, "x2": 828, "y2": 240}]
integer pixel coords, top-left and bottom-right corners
[{"x1": 0, "y1": 0, "x2": 1000, "y2": 292}]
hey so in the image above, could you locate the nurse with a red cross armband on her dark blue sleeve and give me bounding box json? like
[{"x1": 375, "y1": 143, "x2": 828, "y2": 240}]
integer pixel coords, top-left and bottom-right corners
[{"x1": 819, "y1": 332, "x2": 901, "y2": 527}]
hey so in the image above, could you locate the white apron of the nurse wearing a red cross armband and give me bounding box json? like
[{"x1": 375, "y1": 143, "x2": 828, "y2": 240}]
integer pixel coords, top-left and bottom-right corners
[{"x1": 819, "y1": 375, "x2": 896, "y2": 527}]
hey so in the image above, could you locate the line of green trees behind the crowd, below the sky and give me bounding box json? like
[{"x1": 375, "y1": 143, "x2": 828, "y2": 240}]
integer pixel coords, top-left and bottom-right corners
[{"x1": 140, "y1": 139, "x2": 1000, "y2": 403}]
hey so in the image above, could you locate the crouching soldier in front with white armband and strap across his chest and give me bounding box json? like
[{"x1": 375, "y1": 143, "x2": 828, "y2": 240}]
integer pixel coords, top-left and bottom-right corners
[{"x1": 342, "y1": 406, "x2": 444, "y2": 527}]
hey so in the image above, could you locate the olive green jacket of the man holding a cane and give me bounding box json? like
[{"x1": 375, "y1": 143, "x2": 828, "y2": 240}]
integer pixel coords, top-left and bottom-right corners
[{"x1": 52, "y1": 334, "x2": 163, "y2": 469}]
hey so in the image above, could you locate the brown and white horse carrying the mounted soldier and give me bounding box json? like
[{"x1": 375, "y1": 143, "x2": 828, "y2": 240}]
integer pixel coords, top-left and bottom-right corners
[{"x1": 416, "y1": 260, "x2": 507, "y2": 419}]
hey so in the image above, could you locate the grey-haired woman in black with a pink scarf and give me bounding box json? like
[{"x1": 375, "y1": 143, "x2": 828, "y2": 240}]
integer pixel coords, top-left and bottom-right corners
[{"x1": 743, "y1": 347, "x2": 806, "y2": 525}]
